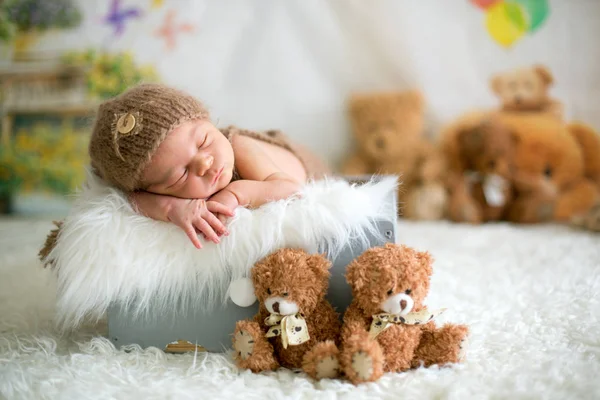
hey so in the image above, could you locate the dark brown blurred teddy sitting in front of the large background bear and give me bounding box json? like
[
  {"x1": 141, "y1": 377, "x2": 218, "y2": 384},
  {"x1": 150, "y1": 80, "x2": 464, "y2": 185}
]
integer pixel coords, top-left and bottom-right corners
[{"x1": 447, "y1": 116, "x2": 515, "y2": 223}]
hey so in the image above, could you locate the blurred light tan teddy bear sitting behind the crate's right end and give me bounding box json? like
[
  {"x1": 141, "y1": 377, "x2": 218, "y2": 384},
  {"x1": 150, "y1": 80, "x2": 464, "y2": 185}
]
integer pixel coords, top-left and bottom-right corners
[{"x1": 341, "y1": 90, "x2": 447, "y2": 220}]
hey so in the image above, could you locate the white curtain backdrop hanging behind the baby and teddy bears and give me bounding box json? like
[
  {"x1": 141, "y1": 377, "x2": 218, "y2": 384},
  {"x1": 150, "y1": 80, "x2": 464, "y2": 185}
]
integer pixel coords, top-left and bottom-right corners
[{"x1": 40, "y1": 0, "x2": 600, "y2": 168}]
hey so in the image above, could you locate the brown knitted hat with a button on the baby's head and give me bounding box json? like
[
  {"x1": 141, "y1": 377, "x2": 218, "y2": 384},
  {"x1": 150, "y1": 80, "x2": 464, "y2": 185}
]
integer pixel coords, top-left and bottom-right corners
[{"x1": 89, "y1": 83, "x2": 209, "y2": 191}]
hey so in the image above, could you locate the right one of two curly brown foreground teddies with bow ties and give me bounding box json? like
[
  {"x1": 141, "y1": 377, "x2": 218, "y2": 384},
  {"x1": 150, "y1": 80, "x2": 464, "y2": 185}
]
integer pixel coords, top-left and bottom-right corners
[{"x1": 340, "y1": 243, "x2": 469, "y2": 384}]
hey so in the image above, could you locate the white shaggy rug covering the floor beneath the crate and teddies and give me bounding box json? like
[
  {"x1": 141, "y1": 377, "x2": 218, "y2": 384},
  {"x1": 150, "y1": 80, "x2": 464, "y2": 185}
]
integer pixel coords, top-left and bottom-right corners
[{"x1": 0, "y1": 221, "x2": 600, "y2": 399}]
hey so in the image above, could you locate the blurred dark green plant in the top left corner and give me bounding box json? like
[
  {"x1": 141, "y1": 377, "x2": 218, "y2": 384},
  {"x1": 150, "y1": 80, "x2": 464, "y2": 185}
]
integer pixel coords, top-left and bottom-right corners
[{"x1": 3, "y1": 0, "x2": 82, "y2": 32}]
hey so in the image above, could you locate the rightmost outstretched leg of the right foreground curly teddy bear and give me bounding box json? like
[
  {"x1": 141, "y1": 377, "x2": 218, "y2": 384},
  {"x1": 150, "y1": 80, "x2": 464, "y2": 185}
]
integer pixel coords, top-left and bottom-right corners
[{"x1": 412, "y1": 324, "x2": 469, "y2": 368}]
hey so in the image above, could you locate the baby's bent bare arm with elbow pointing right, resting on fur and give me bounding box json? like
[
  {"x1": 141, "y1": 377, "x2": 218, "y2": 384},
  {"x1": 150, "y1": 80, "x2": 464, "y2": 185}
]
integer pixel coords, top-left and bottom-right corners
[{"x1": 210, "y1": 136, "x2": 301, "y2": 208}]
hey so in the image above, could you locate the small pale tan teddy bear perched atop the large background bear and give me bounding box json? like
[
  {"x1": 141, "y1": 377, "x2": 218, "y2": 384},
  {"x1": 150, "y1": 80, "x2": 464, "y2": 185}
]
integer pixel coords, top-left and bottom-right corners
[{"x1": 491, "y1": 65, "x2": 563, "y2": 121}]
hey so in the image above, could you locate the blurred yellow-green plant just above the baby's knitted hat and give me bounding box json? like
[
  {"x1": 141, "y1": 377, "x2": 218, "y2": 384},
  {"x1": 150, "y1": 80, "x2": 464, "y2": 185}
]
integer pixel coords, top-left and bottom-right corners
[{"x1": 63, "y1": 50, "x2": 158, "y2": 99}]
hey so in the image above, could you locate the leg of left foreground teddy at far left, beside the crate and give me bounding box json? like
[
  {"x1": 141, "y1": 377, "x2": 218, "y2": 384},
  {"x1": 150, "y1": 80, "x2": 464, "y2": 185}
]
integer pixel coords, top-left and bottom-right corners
[{"x1": 233, "y1": 321, "x2": 279, "y2": 372}]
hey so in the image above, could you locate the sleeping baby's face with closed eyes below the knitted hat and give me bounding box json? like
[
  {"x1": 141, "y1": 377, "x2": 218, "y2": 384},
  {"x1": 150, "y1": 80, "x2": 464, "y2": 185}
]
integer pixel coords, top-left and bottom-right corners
[{"x1": 142, "y1": 120, "x2": 233, "y2": 199}]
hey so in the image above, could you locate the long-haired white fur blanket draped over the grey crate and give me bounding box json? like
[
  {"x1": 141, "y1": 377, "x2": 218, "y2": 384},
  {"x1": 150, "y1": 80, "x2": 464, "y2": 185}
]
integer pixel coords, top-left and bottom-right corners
[{"x1": 49, "y1": 175, "x2": 397, "y2": 328}]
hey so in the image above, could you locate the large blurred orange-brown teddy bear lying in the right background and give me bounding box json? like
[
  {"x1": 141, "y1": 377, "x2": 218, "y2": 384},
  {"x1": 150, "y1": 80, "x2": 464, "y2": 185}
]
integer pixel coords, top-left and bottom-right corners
[{"x1": 440, "y1": 111, "x2": 600, "y2": 223}]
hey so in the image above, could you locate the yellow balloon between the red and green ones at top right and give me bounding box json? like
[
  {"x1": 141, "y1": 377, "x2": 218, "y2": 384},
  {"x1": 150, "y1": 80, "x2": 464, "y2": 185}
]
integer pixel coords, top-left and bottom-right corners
[{"x1": 485, "y1": 2, "x2": 527, "y2": 47}]
